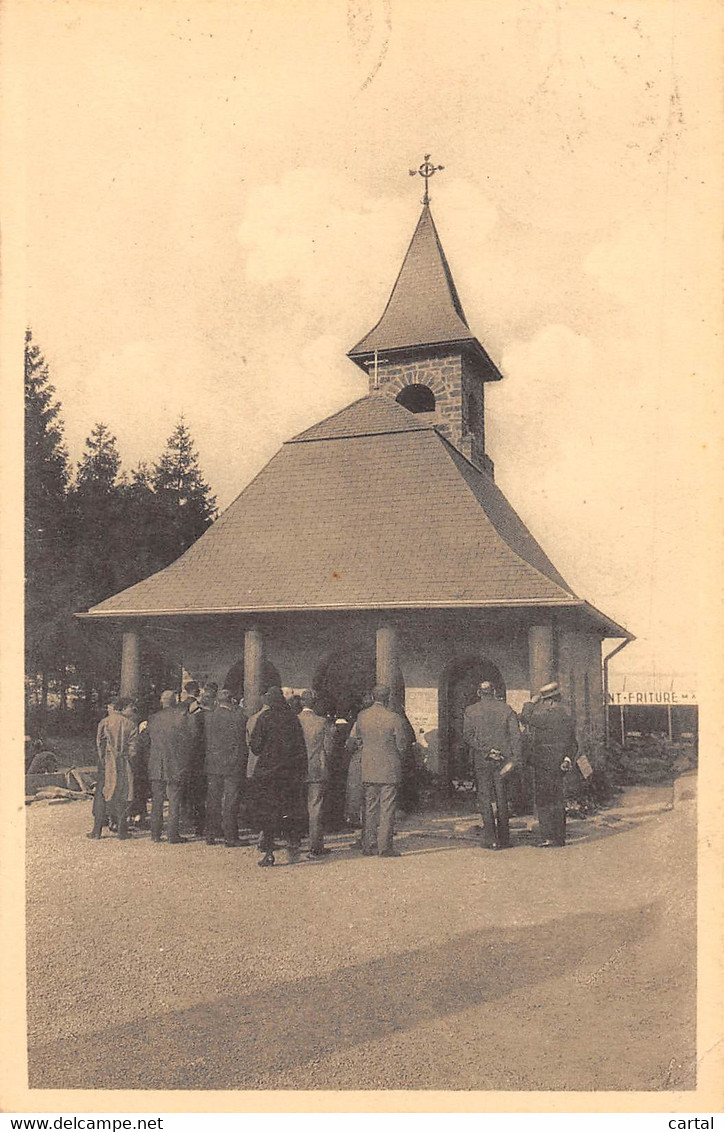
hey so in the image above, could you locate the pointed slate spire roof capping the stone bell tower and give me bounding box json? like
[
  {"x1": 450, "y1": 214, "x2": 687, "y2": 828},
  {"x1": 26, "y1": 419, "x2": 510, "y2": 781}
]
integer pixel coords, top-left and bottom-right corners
[{"x1": 348, "y1": 205, "x2": 502, "y2": 380}]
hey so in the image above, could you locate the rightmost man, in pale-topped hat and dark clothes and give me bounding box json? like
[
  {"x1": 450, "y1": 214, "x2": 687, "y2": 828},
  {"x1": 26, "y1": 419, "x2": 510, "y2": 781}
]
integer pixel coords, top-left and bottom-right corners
[{"x1": 520, "y1": 684, "x2": 578, "y2": 849}]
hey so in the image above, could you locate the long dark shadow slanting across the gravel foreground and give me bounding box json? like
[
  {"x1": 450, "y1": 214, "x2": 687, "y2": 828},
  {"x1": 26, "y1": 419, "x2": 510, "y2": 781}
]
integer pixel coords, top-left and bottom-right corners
[{"x1": 29, "y1": 904, "x2": 687, "y2": 1089}]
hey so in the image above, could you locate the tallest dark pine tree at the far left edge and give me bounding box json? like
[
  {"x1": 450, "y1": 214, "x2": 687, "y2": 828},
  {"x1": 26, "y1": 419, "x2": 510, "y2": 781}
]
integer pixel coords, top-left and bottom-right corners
[{"x1": 25, "y1": 329, "x2": 70, "y2": 701}]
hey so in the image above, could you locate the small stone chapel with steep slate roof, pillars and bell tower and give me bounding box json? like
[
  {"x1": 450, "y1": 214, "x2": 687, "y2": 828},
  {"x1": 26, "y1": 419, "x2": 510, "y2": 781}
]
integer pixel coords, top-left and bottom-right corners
[{"x1": 79, "y1": 189, "x2": 630, "y2": 784}]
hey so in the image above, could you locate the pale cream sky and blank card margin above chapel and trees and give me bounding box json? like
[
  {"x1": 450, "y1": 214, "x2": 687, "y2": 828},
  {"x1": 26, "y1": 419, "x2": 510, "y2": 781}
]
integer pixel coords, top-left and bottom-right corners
[{"x1": 3, "y1": 0, "x2": 721, "y2": 672}]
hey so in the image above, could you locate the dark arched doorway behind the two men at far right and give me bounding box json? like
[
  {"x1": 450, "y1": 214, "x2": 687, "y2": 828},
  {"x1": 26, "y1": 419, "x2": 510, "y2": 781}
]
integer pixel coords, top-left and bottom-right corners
[{"x1": 439, "y1": 657, "x2": 506, "y2": 784}]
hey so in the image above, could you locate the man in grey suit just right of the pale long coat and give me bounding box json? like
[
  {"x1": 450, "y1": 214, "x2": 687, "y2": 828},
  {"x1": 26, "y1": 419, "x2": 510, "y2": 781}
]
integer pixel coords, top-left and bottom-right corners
[{"x1": 146, "y1": 691, "x2": 200, "y2": 844}]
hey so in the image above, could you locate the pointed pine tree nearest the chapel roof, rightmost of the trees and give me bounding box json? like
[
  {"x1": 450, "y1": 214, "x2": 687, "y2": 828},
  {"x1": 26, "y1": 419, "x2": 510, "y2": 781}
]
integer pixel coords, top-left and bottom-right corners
[{"x1": 152, "y1": 418, "x2": 216, "y2": 565}]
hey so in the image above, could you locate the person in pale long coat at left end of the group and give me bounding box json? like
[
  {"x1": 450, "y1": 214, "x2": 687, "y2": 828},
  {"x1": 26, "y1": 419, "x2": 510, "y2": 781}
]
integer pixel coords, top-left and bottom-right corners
[{"x1": 88, "y1": 700, "x2": 138, "y2": 841}]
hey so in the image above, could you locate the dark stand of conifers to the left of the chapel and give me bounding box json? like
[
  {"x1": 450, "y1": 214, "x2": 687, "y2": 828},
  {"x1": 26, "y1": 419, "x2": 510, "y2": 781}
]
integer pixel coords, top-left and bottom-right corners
[{"x1": 25, "y1": 329, "x2": 216, "y2": 729}]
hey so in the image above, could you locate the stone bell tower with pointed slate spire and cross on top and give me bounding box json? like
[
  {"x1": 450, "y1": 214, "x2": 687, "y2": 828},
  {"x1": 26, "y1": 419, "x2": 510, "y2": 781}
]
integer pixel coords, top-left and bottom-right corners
[{"x1": 347, "y1": 154, "x2": 502, "y2": 477}]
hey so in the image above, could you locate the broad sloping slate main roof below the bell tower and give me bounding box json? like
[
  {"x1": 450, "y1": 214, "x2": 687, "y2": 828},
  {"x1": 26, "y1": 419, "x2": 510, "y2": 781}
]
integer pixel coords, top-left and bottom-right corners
[{"x1": 80, "y1": 393, "x2": 624, "y2": 617}]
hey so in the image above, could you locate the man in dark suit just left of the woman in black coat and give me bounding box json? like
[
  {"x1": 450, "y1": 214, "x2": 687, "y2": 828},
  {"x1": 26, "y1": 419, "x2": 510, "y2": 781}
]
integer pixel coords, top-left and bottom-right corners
[{"x1": 202, "y1": 688, "x2": 248, "y2": 849}]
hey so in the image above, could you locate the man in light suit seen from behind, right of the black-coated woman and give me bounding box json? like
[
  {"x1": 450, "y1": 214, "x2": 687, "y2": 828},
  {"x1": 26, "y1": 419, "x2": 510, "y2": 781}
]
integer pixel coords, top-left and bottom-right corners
[{"x1": 347, "y1": 684, "x2": 407, "y2": 857}]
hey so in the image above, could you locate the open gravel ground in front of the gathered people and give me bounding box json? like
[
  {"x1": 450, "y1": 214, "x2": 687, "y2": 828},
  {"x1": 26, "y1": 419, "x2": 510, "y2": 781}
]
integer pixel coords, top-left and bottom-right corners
[{"x1": 27, "y1": 791, "x2": 696, "y2": 1090}]
